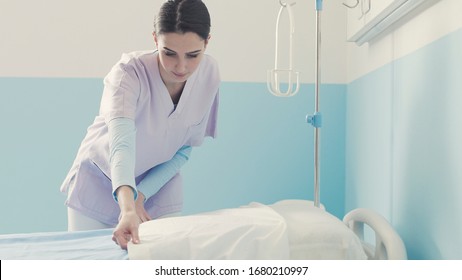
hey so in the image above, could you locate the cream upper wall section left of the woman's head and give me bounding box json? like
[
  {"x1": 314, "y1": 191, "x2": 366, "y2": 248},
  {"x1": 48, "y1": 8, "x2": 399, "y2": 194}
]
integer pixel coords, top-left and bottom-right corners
[{"x1": 0, "y1": 0, "x2": 162, "y2": 78}]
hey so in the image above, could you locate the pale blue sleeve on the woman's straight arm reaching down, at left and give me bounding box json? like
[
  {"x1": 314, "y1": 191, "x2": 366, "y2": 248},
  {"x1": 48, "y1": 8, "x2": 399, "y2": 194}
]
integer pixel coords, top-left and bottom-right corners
[{"x1": 108, "y1": 118, "x2": 138, "y2": 201}]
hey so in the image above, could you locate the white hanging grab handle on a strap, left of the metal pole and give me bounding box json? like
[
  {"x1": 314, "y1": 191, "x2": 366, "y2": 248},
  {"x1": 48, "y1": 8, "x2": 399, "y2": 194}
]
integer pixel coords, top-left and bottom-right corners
[{"x1": 267, "y1": 0, "x2": 300, "y2": 97}]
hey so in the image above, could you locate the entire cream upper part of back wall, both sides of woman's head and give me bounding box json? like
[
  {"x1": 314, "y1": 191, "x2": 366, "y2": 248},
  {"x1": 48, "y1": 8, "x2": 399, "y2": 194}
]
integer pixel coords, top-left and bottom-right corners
[{"x1": 0, "y1": 0, "x2": 346, "y2": 83}]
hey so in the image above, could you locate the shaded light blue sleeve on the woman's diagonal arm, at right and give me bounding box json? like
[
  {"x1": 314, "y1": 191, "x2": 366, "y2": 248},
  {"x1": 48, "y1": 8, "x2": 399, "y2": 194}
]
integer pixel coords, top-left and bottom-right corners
[{"x1": 137, "y1": 146, "x2": 192, "y2": 200}]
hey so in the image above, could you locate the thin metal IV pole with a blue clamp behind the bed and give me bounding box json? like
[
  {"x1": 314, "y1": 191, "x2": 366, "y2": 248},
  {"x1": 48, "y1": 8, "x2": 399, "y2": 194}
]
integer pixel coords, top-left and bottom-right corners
[{"x1": 306, "y1": 0, "x2": 322, "y2": 207}]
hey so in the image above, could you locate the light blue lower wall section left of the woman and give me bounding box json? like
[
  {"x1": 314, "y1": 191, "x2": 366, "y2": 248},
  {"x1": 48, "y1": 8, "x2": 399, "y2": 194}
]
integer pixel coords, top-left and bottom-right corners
[{"x1": 0, "y1": 78, "x2": 102, "y2": 233}]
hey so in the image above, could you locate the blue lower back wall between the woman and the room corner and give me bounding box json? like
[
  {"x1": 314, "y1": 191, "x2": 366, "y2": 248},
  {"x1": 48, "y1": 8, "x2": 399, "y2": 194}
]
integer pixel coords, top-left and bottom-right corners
[{"x1": 184, "y1": 83, "x2": 346, "y2": 217}]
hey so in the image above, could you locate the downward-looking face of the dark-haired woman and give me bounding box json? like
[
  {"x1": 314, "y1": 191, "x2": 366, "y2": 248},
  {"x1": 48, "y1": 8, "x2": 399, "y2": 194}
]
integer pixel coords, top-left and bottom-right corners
[{"x1": 153, "y1": 32, "x2": 208, "y2": 86}]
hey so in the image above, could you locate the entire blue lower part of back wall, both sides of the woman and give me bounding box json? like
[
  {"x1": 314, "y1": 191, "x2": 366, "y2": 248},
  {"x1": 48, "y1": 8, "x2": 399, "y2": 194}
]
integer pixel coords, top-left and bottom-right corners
[{"x1": 0, "y1": 78, "x2": 346, "y2": 234}]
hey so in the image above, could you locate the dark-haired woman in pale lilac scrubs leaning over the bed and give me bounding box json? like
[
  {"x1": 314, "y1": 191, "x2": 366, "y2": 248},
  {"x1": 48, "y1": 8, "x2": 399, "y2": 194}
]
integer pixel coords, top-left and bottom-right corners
[{"x1": 61, "y1": 0, "x2": 220, "y2": 249}]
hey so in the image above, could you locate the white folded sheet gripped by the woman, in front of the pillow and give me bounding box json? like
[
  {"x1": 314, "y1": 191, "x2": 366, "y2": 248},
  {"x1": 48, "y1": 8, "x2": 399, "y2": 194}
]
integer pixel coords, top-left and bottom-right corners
[{"x1": 128, "y1": 203, "x2": 289, "y2": 260}]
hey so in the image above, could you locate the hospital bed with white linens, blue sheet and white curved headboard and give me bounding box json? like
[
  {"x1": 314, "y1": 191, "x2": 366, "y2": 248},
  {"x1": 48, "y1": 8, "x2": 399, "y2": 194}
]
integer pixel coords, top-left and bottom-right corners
[{"x1": 0, "y1": 200, "x2": 406, "y2": 260}]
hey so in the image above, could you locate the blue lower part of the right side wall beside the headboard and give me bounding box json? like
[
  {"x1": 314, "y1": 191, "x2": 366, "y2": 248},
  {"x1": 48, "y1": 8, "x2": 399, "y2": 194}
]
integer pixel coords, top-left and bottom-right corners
[{"x1": 346, "y1": 30, "x2": 462, "y2": 259}]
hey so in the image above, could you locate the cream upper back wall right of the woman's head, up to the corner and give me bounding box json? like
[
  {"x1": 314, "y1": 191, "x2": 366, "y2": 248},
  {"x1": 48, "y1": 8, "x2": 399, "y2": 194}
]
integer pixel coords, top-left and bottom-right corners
[{"x1": 207, "y1": 0, "x2": 346, "y2": 83}]
